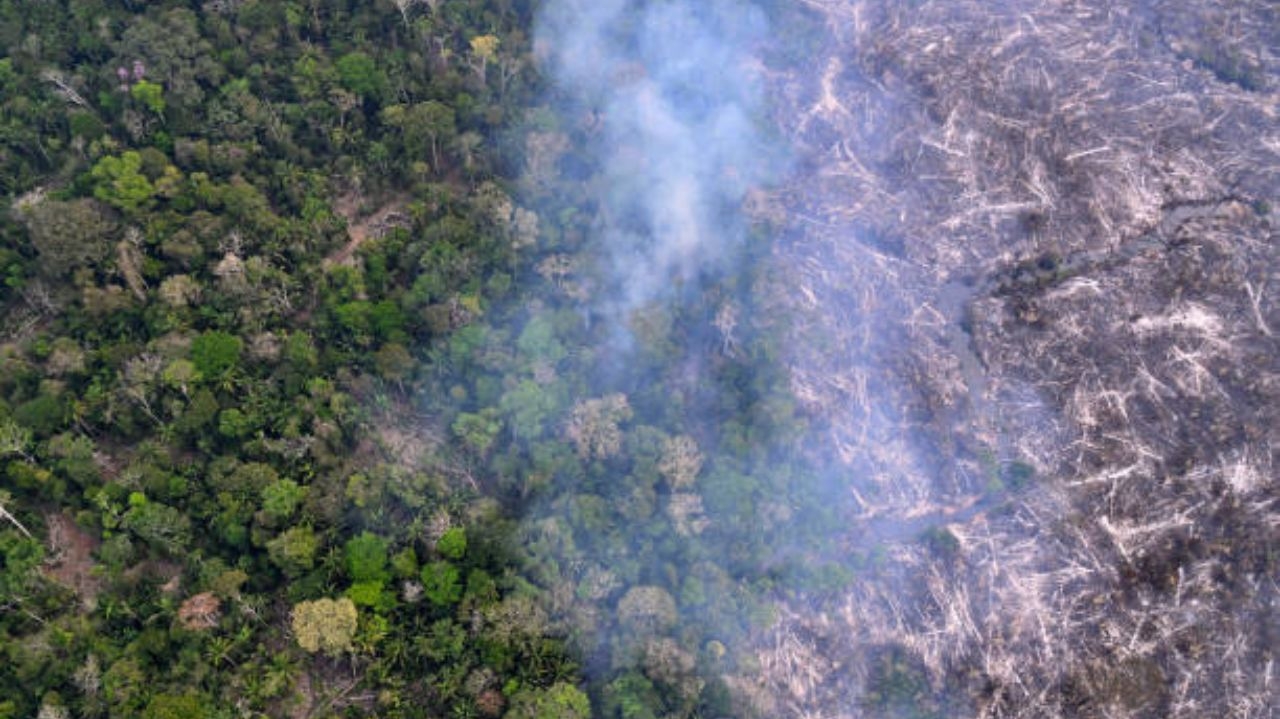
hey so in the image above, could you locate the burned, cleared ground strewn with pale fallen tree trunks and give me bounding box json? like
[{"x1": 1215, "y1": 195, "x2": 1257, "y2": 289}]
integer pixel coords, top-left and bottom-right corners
[{"x1": 750, "y1": 0, "x2": 1280, "y2": 718}]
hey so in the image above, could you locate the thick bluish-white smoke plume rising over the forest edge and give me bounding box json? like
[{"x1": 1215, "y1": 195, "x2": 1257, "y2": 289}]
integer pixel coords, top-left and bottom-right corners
[{"x1": 536, "y1": 0, "x2": 778, "y2": 312}]
